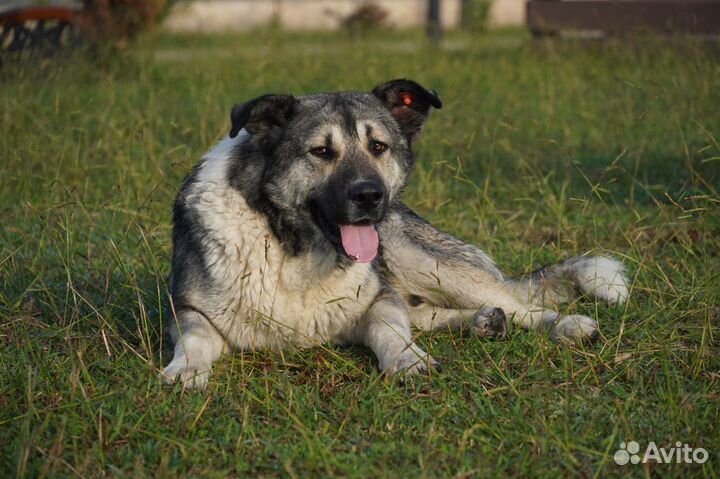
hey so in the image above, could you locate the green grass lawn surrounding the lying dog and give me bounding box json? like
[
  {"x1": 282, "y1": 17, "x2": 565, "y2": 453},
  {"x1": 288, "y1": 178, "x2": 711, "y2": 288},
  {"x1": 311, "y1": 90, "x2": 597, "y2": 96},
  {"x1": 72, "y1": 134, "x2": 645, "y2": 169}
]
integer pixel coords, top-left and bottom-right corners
[{"x1": 0, "y1": 32, "x2": 720, "y2": 477}]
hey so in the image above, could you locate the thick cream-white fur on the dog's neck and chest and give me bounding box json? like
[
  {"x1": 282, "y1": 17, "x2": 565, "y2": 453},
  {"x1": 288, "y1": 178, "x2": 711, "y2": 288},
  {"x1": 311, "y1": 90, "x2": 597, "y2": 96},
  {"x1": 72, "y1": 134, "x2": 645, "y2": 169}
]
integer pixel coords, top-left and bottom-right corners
[{"x1": 186, "y1": 138, "x2": 379, "y2": 349}]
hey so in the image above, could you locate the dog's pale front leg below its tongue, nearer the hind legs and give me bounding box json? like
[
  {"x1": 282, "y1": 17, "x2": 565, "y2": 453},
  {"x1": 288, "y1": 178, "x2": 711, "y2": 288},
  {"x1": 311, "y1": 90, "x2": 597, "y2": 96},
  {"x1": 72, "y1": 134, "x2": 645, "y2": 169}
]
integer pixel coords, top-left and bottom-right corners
[{"x1": 358, "y1": 292, "x2": 439, "y2": 375}]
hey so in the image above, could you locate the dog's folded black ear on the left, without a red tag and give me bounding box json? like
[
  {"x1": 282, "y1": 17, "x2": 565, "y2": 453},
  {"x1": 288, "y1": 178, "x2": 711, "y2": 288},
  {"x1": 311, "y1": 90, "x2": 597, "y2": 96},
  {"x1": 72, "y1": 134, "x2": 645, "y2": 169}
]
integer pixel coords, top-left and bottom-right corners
[{"x1": 230, "y1": 95, "x2": 295, "y2": 138}]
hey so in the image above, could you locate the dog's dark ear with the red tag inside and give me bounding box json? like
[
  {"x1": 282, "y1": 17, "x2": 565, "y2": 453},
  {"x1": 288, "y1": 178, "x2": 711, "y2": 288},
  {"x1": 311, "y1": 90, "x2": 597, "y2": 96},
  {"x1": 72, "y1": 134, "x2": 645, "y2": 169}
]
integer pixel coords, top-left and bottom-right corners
[{"x1": 372, "y1": 80, "x2": 442, "y2": 141}]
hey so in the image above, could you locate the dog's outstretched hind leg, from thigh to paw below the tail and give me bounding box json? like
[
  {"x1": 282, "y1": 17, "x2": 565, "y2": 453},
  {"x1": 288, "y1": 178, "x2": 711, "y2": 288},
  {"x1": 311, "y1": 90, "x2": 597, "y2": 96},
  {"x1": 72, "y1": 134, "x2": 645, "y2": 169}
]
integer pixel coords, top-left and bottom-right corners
[{"x1": 380, "y1": 206, "x2": 599, "y2": 342}]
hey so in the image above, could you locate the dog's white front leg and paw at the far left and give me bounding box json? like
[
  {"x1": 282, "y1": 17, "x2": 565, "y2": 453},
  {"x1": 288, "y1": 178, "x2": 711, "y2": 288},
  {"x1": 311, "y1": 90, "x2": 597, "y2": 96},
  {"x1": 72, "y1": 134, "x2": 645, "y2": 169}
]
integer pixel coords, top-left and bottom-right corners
[{"x1": 160, "y1": 309, "x2": 225, "y2": 389}]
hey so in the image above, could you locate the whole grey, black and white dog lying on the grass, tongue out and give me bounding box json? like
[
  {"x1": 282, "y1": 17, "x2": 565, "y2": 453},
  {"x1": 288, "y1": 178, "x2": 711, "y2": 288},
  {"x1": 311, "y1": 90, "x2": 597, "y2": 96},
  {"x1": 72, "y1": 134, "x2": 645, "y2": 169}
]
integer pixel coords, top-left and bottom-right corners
[{"x1": 161, "y1": 80, "x2": 628, "y2": 388}]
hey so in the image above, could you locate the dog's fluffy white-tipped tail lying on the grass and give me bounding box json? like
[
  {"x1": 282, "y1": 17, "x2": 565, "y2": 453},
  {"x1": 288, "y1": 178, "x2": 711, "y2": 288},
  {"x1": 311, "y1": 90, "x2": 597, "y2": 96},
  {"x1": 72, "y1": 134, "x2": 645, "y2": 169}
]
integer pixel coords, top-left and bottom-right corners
[{"x1": 509, "y1": 256, "x2": 628, "y2": 306}]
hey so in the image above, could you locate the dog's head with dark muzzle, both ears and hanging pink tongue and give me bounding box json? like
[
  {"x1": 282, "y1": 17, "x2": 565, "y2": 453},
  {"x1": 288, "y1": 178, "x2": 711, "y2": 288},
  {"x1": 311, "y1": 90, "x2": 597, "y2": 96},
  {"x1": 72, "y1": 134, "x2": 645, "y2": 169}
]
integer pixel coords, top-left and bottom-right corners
[{"x1": 230, "y1": 80, "x2": 442, "y2": 262}]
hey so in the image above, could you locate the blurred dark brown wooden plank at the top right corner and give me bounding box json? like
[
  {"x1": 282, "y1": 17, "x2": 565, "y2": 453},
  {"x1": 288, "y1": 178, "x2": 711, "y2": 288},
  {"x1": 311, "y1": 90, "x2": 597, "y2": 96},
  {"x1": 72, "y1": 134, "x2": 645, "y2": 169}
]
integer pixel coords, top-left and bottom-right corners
[{"x1": 527, "y1": 0, "x2": 720, "y2": 34}]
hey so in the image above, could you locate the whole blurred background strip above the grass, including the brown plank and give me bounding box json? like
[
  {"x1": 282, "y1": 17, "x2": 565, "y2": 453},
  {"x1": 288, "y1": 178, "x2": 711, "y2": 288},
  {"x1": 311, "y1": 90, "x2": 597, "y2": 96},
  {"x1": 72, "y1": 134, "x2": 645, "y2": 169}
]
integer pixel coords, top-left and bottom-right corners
[{"x1": 0, "y1": 0, "x2": 720, "y2": 51}]
